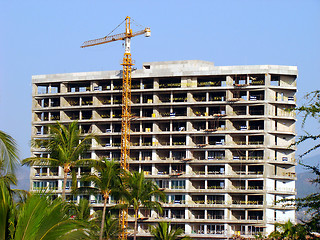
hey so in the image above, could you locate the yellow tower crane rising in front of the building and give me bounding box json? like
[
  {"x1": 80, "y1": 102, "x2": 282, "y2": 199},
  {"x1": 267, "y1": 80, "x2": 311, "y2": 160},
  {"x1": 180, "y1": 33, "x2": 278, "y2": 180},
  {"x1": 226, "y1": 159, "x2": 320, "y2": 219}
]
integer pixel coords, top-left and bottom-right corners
[{"x1": 81, "y1": 17, "x2": 151, "y2": 239}]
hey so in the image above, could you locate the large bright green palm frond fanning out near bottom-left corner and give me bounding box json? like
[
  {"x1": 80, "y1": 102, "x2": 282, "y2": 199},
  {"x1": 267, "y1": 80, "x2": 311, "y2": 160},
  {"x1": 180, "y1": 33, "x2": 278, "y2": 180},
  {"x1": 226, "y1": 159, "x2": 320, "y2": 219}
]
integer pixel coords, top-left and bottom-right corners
[{"x1": 15, "y1": 194, "x2": 86, "y2": 240}]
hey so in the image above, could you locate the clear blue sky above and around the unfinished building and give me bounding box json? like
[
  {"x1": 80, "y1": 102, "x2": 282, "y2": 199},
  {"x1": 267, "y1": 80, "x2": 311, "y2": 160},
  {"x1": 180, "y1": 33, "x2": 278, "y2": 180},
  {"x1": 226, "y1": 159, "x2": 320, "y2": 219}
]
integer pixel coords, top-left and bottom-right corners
[{"x1": 0, "y1": 0, "x2": 320, "y2": 184}]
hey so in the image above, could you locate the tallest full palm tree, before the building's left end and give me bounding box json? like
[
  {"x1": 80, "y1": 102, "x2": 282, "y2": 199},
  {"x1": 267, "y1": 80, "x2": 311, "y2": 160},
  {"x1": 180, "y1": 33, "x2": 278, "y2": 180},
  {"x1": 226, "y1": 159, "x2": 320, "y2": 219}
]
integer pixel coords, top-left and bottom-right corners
[{"x1": 22, "y1": 121, "x2": 96, "y2": 200}]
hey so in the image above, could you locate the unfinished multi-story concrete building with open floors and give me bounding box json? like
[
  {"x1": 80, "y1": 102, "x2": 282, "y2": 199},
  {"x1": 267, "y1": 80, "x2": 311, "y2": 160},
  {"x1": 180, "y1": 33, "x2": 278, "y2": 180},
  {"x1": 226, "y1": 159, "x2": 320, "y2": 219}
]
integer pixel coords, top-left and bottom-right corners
[{"x1": 31, "y1": 61, "x2": 297, "y2": 239}]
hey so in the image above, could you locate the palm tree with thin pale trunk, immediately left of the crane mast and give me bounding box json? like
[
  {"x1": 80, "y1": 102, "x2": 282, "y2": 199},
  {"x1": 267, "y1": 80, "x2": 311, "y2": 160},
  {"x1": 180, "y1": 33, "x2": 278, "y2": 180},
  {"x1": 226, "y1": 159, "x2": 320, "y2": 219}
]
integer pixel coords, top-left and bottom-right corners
[{"x1": 80, "y1": 159, "x2": 121, "y2": 240}]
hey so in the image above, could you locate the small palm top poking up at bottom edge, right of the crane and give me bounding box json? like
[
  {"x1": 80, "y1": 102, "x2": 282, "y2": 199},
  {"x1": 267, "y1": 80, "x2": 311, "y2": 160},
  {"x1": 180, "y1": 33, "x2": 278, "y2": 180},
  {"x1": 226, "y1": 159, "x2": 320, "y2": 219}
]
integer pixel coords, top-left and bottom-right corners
[{"x1": 150, "y1": 222, "x2": 191, "y2": 240}]
